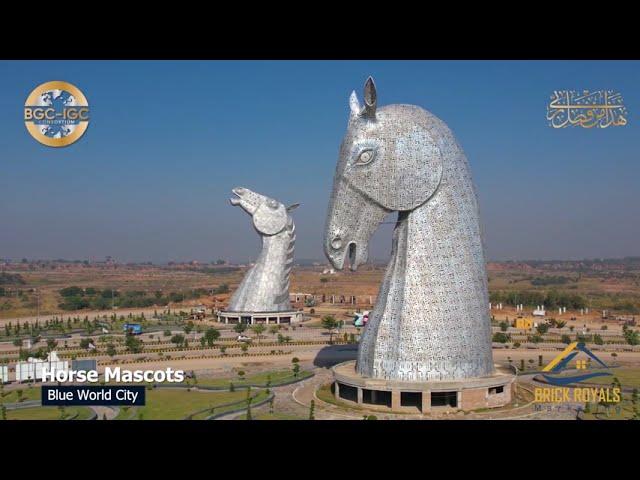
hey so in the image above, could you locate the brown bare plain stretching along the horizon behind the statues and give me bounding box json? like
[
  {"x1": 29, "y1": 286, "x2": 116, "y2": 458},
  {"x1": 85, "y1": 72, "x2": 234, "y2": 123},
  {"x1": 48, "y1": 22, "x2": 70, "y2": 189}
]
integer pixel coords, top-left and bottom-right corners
[{"x1": 0, "y1": 259, "x2": 640, "y2": 319}]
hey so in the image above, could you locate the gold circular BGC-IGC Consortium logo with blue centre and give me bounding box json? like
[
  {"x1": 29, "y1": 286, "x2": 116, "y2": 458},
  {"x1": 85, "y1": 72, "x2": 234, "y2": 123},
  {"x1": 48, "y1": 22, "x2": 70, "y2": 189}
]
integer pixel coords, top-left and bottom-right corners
[{"x1": 24, "y1": 81, "x2": 89, "y2": 147}]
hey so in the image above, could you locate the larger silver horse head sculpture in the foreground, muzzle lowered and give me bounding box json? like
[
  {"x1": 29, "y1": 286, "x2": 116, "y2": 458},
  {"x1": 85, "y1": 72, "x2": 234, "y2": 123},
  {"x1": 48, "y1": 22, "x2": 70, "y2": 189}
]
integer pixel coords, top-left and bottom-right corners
[{"x1": 324, "y1": 78, "x2": 493, "y2": 381}]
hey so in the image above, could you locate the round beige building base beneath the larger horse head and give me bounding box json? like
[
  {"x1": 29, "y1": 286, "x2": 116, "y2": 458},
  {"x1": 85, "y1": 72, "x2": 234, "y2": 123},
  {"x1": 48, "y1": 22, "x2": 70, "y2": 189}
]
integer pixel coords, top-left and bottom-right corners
[{"x1": 333, "y1": 360, "x2": 515, "y2": 414}]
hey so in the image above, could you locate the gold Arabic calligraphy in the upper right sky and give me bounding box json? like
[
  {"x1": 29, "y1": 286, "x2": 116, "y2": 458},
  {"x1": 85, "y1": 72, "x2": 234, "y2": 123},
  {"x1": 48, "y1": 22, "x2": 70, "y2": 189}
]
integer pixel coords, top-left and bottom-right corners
[{"x1": 547, "y1": 90, "x2": 627, "y2": 128}]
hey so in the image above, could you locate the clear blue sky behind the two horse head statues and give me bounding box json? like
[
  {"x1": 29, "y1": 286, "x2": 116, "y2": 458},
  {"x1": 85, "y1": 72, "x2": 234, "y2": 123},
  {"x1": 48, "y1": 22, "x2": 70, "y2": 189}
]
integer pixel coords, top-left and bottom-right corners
[{"x1": 0, "y1": 61, "x2": 640, "y2": 262}]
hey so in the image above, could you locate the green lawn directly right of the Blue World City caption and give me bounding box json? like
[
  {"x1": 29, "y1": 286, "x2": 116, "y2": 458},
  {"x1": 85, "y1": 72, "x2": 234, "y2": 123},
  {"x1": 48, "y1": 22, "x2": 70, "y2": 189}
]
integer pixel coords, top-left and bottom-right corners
[{"x1": 132, "y1": 389, "x2": 267, "y2": 420}]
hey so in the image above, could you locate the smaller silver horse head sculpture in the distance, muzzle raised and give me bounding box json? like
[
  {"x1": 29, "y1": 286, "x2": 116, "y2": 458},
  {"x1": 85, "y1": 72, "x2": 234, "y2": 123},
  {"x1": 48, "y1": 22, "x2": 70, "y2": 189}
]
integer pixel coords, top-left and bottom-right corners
[{"x1": 228, "y1": 187, "x2": 299, "y2": 312}]
